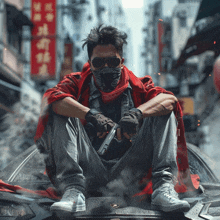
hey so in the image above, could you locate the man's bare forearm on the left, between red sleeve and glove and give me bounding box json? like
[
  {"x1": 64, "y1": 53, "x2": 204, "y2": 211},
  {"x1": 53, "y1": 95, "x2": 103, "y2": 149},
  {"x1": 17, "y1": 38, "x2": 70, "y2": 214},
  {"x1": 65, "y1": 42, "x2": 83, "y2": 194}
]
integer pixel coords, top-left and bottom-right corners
[{"x1": 52, "y1": 97, "x2": 90, "y2": 119}]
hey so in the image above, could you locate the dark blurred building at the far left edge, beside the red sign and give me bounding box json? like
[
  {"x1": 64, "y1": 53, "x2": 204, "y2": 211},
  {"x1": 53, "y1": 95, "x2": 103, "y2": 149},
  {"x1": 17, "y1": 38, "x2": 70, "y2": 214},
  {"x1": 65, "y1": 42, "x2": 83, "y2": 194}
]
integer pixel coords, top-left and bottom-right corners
[{"x1": 0, "y1": 0, "x2": 33, "y2": 117}]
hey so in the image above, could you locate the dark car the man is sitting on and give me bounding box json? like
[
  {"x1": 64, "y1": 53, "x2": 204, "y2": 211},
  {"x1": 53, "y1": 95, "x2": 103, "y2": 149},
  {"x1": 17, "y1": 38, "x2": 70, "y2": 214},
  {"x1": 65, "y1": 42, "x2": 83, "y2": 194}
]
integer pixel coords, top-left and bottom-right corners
[{"x1": 0, "y1": 143, "x2": 220, "y2": 220}]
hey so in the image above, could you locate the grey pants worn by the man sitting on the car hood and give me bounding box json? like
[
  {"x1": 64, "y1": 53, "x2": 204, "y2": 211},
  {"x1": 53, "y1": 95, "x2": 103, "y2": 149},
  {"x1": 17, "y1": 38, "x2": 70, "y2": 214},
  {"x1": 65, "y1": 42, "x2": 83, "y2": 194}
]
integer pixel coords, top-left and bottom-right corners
[{"x1": 37, "y1": 112, "x2": 177, "y2": 196}]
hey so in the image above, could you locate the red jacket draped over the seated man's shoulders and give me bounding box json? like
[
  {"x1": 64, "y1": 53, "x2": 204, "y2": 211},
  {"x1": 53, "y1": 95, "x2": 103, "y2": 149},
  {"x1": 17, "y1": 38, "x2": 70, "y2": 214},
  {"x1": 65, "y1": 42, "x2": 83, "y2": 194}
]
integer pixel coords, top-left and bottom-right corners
[{"x1": 35, "y1": 63, "x2": 198, "y2": 192}]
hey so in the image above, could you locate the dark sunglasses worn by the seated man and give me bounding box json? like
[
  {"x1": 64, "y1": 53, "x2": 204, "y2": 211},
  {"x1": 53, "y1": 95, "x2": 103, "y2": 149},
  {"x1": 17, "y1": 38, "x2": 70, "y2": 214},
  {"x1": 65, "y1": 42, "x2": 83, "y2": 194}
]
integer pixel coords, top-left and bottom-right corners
[{"x1": 92, "y1": 57, "x2": 121, "y2": 68}]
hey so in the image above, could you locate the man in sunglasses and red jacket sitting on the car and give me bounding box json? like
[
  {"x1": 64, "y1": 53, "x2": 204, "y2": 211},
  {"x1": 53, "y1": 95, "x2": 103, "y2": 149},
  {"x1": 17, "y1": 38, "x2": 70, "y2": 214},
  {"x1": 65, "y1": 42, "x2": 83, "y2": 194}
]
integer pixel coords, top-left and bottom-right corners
[{"x1": 36, "y1": 26, "x2": 190, "y2": 212}]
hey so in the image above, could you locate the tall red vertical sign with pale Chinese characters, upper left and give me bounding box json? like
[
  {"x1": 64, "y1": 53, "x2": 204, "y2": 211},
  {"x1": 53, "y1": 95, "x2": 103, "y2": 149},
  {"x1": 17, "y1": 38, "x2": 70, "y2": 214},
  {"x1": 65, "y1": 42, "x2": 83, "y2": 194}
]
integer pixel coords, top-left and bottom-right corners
[{"x1": 31, "y1": 0, "x2": 56, "y2": 81}]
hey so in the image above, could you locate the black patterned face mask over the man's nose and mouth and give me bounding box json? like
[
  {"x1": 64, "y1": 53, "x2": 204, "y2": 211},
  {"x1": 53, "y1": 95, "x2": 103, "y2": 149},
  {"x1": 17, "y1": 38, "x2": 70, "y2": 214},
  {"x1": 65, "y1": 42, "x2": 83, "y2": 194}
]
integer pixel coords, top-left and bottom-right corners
[{"x1": 92, "y1": 67, "x2": 121, "y2": 92}]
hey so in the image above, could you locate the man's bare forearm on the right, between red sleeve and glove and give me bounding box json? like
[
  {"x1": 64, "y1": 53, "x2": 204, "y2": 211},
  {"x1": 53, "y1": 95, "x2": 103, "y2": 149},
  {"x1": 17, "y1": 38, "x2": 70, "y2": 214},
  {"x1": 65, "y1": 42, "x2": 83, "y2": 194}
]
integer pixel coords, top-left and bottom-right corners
[{"x1": 138, "y1": 93, "x2": 178, "y2": 118}]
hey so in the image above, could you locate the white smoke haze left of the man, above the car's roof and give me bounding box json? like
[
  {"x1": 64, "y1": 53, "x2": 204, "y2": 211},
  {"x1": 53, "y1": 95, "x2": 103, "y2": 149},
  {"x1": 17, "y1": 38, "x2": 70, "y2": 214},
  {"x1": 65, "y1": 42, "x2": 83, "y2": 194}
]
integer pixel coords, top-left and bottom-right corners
[{"x1": 0, "y1": 102, "x2": 39, "y2": 169}]
